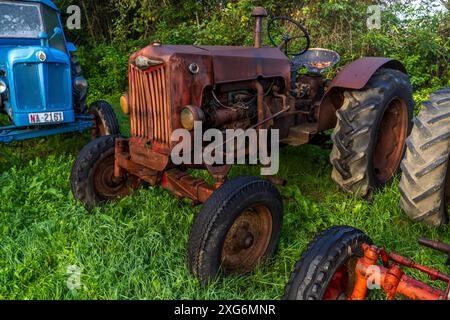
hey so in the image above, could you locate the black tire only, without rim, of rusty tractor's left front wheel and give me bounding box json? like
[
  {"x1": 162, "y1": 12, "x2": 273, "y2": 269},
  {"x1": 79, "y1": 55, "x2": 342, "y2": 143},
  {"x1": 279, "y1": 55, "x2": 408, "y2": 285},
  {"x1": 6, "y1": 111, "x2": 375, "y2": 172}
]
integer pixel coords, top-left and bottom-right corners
[{"x1": 70, "y1": 136, "x2": 140, "y2": 210}]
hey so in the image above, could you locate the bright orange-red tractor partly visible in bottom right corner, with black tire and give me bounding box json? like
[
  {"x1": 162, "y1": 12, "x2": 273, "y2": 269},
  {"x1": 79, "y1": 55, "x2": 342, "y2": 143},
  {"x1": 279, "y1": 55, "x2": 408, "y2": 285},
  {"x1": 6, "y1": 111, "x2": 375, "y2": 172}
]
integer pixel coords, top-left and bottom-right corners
[{"x1": 284, "y1": 226, "x2": 450, "y2": 300}]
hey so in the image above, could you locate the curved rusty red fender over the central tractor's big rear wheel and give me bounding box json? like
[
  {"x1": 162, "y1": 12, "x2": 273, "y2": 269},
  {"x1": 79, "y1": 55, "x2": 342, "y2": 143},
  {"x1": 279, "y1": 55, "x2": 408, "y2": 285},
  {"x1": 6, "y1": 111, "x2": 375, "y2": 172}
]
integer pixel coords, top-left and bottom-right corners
[{"x1": 318, "y1": 57, "x2": 407, "y2": 132}]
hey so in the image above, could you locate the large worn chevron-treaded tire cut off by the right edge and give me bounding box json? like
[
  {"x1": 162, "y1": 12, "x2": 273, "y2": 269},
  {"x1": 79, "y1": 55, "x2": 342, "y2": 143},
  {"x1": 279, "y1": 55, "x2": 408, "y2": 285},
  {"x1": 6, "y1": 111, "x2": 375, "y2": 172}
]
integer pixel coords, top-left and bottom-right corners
[{"x1": 400, "y1": 88, "x2": 450, "y2": 226}]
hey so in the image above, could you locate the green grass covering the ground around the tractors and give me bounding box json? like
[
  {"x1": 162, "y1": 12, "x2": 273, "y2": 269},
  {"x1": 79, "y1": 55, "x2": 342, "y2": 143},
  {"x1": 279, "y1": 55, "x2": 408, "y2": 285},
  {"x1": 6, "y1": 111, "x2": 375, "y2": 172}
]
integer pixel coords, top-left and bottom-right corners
[{"x1": 0, "y1": 99, "x2": 450, "y2": 299}]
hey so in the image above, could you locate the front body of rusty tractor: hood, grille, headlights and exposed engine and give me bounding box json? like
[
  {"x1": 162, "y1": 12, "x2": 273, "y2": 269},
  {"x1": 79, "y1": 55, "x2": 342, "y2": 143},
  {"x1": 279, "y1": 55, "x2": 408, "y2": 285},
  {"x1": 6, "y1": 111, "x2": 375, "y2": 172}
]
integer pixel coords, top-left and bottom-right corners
[{"x1": 121, "y1": 42, "x2": 292, "y2": 155}]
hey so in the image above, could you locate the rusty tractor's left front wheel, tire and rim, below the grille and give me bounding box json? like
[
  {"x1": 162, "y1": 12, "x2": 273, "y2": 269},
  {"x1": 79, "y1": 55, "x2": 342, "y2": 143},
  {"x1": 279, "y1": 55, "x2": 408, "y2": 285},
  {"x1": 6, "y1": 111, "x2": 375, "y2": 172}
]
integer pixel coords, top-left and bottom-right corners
[{"x1": 70, "y1": 136, "x2": 140, "y2": 210}]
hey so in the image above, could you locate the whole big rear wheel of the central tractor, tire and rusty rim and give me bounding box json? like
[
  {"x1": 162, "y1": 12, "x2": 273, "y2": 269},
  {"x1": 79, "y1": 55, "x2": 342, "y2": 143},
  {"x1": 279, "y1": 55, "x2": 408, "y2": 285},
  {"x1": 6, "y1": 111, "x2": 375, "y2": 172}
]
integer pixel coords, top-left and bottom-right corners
[{"x1": 331, "y1": 69, "x2": 414, "y2": 198}]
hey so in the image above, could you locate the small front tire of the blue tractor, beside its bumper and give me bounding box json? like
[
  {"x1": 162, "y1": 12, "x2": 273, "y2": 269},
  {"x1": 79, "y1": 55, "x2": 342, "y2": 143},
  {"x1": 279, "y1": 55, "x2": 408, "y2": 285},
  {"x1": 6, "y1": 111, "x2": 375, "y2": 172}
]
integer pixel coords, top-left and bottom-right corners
[{"x1": 89, "y1": 100, "x2": 120, "y2": 138}]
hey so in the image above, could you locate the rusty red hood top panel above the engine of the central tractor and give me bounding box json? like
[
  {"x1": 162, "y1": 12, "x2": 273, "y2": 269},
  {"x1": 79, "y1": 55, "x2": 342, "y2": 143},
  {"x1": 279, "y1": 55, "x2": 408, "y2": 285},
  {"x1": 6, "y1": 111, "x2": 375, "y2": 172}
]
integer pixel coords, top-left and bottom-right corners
[{"x1": 130, "y1": 45, "x2": 290, "y2": 84}]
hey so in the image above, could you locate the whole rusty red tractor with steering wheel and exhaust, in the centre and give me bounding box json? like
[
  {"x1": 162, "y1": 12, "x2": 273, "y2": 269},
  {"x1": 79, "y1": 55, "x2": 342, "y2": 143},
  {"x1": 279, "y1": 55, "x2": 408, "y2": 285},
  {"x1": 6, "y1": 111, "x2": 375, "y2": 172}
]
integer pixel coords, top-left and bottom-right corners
[{"x1": 71, "y1": 7, "x2": 413, "y2": 282}]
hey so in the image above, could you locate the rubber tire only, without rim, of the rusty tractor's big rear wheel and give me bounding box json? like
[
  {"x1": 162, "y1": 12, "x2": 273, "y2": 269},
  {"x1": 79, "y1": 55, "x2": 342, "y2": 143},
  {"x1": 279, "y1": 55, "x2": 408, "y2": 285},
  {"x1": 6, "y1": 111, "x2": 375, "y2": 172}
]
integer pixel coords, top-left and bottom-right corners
[{"x1": 330, "y1": 68, "x2": 414, "y2": 197}]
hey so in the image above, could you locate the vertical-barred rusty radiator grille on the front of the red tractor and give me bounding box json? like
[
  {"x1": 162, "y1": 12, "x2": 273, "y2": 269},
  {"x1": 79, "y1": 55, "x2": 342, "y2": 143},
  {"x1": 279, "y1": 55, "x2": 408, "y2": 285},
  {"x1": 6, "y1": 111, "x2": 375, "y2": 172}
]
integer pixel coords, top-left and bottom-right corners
[{"x1": 129, "y1": 65, "x2": 171, "y2": 145}]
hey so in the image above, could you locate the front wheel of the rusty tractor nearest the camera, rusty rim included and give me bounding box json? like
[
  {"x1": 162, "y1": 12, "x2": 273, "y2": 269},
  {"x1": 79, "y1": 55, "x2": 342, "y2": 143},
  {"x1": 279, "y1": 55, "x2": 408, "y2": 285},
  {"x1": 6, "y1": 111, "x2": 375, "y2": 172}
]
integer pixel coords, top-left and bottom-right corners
[{"x1": 187, "y1": 177, "x2": 283, "y2": 284}]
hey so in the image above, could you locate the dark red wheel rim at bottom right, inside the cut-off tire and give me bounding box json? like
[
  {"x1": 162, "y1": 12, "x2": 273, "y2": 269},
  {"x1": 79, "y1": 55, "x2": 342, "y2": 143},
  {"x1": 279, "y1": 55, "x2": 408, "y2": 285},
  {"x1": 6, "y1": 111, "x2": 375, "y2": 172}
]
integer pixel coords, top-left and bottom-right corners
[{"x1": 322, "y1": 258, "x2": 358, "y2": 300}]
